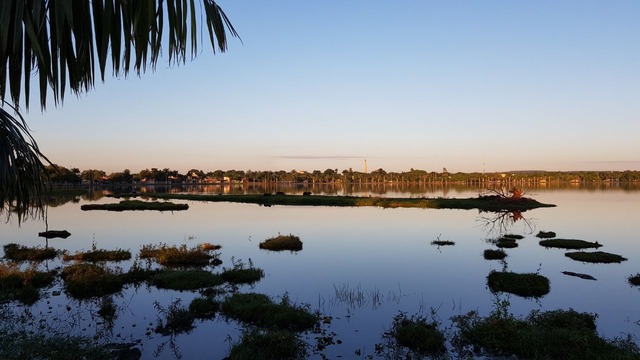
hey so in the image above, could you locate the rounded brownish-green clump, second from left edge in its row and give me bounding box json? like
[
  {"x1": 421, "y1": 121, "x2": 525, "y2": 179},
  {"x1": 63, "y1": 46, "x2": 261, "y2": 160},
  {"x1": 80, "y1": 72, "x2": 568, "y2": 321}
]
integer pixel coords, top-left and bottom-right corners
[{"x1": 61, "y1": 263, "x2": 124, "y2": 299}]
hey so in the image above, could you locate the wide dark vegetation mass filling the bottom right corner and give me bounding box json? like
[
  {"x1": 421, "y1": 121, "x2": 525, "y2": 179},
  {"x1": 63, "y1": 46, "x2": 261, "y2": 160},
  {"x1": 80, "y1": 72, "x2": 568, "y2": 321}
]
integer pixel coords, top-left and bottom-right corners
[{"x1": 453, "y1": 309, "x2": 640, "y2": 360}]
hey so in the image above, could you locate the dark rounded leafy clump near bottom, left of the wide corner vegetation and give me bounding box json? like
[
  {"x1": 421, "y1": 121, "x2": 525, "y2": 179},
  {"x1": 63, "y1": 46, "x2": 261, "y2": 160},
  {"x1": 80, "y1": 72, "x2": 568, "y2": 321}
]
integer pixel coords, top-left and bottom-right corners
[{"x1": 384, "y1": 313, "x2": 447, "y2": 358}]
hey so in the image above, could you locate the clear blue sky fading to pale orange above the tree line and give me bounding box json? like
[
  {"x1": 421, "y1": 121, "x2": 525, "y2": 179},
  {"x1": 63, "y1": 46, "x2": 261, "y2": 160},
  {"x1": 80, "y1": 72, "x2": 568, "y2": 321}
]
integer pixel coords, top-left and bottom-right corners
[{"x1": 24, "y1": 0, "x2": 640, "y2": 173}]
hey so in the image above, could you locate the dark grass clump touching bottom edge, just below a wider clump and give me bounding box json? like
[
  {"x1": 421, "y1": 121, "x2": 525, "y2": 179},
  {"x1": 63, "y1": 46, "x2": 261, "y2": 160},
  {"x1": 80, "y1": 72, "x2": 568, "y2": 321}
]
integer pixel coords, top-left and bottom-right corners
[{"x1": 228, "y1": 329, "x2": 307, "y2": 359}]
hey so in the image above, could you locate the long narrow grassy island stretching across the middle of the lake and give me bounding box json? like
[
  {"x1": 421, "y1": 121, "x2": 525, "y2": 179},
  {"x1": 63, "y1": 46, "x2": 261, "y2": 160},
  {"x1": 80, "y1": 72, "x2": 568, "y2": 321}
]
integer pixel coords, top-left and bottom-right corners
[{"x1": 150, "y1": 193, "x2": 555, "y2": 211}]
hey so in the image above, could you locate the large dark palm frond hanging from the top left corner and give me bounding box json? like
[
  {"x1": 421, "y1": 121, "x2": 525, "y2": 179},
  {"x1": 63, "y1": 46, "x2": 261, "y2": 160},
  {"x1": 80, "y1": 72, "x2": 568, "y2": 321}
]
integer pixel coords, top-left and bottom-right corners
[{"x1": 0, "y1": 0, "x2": 239, "y2": 109}]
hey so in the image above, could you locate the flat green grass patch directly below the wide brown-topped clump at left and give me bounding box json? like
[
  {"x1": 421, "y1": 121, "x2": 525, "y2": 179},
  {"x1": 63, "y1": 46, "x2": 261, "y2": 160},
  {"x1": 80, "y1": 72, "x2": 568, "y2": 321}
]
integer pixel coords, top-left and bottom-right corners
[{"x1": 150, "y1": 270, "x2": 223, "y2": 290}]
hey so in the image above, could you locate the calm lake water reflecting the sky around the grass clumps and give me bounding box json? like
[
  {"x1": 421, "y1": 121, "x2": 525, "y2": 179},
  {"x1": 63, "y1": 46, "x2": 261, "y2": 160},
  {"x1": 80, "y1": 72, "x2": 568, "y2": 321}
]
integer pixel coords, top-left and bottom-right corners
[{"x1": 0, "y1": 184, "x2": 640, "y2": 359}]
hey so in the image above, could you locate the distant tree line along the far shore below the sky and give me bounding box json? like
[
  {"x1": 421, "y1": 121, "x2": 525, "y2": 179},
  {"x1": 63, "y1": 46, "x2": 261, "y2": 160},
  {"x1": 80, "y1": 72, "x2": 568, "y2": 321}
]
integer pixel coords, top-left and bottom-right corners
[{"x1": 47, "y1": 165, "x2": 640, "y2": 185}]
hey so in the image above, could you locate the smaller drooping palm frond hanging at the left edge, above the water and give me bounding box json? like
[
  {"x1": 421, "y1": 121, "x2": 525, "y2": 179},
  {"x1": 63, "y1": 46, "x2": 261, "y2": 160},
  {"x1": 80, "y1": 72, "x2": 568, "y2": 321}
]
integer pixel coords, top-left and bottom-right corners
[{"x1": 0, "y1": 104, "x2": 51, "y2": 222}]
